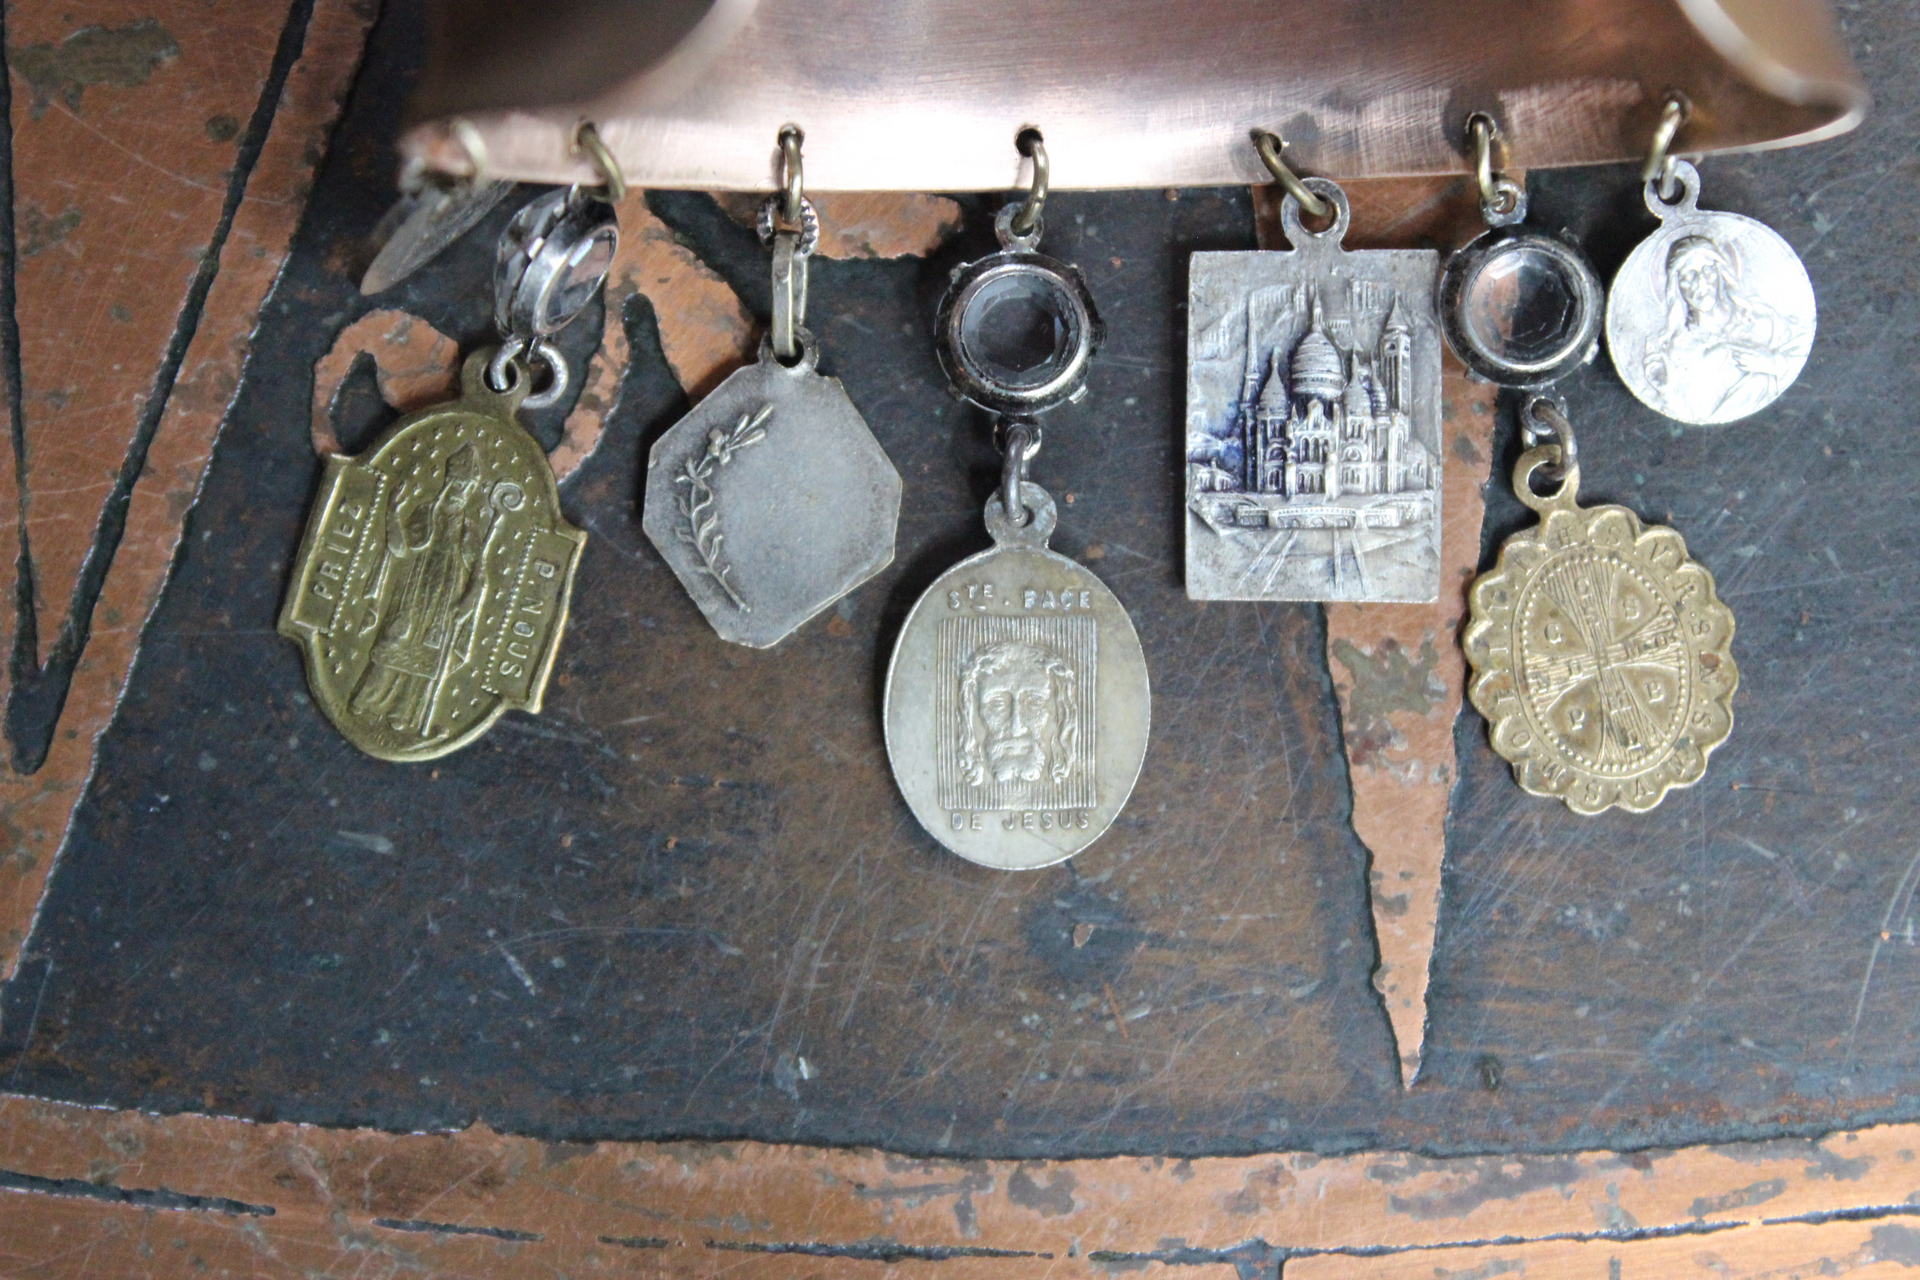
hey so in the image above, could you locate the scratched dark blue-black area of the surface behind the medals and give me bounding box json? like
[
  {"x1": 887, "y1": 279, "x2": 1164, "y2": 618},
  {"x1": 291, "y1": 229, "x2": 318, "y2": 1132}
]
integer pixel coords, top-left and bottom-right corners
[{"x1": 0, "y1": 4, "x2": 1920, "y2": 1176}]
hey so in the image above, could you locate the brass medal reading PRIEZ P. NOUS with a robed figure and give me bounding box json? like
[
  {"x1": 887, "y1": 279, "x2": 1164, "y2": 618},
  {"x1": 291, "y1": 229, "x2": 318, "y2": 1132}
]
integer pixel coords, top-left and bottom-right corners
[{"x1": 278, "y1": 351, "x2": 588, "y2": 760}]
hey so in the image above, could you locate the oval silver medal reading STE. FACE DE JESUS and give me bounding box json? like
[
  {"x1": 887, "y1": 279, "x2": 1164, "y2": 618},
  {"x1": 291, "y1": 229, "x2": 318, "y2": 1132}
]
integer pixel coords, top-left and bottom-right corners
[{"x1": 885, "y1": 482, "x2": 1150, "y2": 871}]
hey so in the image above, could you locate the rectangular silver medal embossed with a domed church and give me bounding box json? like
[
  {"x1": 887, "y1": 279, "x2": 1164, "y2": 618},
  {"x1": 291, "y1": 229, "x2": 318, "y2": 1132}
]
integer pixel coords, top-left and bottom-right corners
[{"x1": 1187, "y1": 178, "x2": 1440, "y2": 603}]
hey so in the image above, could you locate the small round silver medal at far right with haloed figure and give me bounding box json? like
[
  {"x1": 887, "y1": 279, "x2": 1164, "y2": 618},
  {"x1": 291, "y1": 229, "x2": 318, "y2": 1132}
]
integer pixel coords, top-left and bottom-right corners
[{"x1": 1607, "y1": 161, "x2": 1814, "y2": 424}]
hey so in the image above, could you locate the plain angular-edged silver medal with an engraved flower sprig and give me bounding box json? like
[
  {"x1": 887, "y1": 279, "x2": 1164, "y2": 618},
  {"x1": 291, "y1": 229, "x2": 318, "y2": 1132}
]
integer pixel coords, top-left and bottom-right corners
[{"x1": 641, "y1": 338, "x2": 900, "y2": 649}]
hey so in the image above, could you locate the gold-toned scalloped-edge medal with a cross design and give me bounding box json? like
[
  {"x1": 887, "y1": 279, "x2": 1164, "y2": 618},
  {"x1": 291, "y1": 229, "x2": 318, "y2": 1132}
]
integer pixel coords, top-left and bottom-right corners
[{"x1": 1465, "y1": 445, "x2": 1740, "y2": 814}]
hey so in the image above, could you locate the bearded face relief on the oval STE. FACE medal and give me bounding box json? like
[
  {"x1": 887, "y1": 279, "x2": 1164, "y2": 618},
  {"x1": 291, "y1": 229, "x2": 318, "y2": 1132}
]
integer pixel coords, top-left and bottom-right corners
[{"x1": 960, "y1": 639, "x2": 1079, "y2": 787}]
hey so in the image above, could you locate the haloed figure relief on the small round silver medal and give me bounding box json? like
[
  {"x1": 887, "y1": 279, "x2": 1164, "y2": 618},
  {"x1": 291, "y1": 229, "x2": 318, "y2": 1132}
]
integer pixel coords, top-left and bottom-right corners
[{"x1": 1645, "y1": 236, "x2": 1811, "y2": 422}]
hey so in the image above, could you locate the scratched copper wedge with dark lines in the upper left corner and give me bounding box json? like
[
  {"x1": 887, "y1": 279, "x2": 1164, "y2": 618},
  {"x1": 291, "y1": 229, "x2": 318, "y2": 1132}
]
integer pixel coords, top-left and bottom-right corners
[{"x1": 0, "y1": 0, "x2": 372, "y2": 973}]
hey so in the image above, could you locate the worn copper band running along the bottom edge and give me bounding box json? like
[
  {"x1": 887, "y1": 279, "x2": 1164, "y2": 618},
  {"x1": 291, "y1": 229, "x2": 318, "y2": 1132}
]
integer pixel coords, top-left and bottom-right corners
[{"x1": 0, "y1": 1098, "x2": 1920, "y2": 1280}]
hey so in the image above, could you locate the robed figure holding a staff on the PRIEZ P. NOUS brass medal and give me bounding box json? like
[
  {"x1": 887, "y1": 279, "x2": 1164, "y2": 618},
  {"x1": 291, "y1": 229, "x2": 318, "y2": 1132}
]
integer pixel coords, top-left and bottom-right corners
[{"x1": 351, "y1": 445, "x2": 497, "y2": 737}]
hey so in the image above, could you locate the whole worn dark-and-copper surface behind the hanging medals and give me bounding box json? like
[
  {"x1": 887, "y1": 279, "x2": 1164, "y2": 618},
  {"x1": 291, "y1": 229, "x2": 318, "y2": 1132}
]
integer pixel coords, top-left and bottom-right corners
[{"x1": 0, "y1": 0, "x2": 1920, "y2": 1276}]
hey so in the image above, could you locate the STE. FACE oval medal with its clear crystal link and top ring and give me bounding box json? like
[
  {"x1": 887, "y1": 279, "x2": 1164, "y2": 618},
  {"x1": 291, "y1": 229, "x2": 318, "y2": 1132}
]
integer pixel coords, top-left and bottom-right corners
[{"x1": 885, "y1": 132, "x2": 1150, "y2": 871}]
